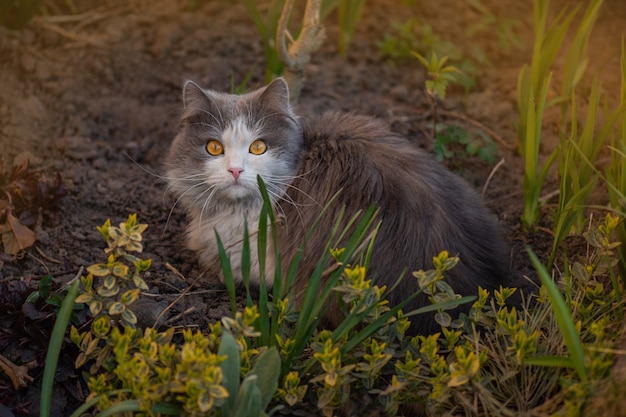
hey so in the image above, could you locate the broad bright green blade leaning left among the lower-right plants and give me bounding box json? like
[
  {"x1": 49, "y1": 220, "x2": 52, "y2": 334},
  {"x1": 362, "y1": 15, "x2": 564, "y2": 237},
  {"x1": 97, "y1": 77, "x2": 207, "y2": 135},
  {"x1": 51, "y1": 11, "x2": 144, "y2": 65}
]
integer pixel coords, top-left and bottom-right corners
[{"x1": 526, "y1": 247, "x2": 587, "y2": 382}]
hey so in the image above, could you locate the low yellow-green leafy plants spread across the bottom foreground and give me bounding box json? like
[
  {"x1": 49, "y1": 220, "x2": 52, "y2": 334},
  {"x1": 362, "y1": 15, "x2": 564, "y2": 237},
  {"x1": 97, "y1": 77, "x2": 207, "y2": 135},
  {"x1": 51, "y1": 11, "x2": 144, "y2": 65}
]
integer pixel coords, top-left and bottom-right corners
[{"x1": 46, "y1": 206, "x2": 623, "y2": 417}]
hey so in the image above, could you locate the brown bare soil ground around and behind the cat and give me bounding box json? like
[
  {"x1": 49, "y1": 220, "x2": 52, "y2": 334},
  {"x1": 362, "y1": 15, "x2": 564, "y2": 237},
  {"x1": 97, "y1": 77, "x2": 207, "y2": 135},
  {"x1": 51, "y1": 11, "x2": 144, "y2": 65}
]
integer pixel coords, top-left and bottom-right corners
[{"x1": 0, "y1": 0, "x2": 626, "y2": 417}]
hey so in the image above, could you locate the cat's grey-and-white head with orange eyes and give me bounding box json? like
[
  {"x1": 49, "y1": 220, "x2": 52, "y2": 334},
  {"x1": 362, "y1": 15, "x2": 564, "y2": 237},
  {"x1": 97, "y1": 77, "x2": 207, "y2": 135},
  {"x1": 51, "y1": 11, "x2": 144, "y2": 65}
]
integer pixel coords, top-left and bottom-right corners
[{"x1": 167, "y1": 79, "x2": 302, "y2": 211}]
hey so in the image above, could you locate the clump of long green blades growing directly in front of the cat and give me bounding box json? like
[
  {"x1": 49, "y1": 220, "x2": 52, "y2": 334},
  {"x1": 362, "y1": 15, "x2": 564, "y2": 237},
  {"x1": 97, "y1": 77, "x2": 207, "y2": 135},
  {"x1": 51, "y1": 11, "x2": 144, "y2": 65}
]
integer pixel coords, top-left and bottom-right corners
[{"x1": 217, "y1": 177, "x2": 476, "y2": 380}]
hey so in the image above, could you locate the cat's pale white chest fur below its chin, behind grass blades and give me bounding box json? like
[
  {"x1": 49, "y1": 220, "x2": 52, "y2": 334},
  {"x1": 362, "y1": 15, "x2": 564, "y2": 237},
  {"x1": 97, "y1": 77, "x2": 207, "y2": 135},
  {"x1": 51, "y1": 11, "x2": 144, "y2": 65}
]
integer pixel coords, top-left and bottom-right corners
[{"x1": 187, "y1": 207, "x2": 275, "y2": 286}]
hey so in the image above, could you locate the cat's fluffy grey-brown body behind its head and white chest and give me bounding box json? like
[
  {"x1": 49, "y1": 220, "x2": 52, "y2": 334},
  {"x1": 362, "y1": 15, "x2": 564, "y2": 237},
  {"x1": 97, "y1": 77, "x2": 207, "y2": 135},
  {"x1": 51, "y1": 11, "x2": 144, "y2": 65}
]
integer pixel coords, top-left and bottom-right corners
[{"x1": 283, "y1": 112, "x2": 509, "y2": 330}]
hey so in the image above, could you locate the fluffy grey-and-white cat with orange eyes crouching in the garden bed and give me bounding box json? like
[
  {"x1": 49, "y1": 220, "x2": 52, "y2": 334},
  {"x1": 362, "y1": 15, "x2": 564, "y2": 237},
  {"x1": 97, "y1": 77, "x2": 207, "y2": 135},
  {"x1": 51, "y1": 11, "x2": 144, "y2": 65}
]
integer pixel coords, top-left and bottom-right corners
[{"x1": 166, "y1": 78, "x2": 518, "y2": 334}]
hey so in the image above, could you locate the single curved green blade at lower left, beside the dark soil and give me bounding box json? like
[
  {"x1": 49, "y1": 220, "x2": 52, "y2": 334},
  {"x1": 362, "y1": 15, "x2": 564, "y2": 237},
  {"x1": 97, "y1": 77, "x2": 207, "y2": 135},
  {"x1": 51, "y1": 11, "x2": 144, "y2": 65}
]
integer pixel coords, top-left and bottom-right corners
[{"x1": 40, "y1": 279, "x2": 80, "y2": 417}]
